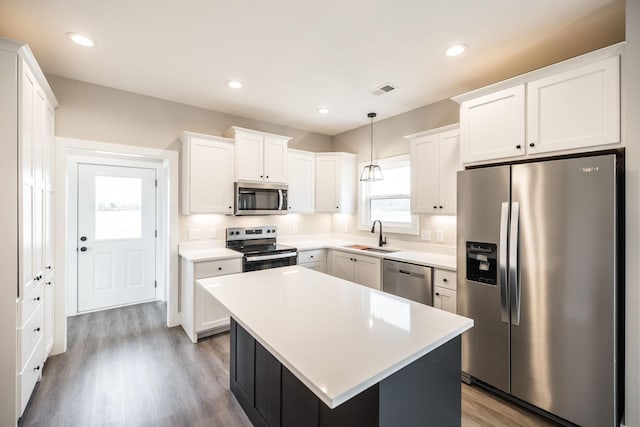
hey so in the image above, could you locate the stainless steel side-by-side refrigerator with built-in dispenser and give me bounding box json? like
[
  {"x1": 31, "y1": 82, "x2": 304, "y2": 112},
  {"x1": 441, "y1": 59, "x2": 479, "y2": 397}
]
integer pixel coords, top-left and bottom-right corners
[{"x1": 457, "y1": 154, "x2": 623, "y2": 426}]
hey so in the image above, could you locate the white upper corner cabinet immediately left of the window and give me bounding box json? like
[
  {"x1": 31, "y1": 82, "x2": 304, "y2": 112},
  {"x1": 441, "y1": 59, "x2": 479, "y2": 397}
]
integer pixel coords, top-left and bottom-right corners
[{"x1": 315, "y1": 153, "x2": 357, "y2": 213}]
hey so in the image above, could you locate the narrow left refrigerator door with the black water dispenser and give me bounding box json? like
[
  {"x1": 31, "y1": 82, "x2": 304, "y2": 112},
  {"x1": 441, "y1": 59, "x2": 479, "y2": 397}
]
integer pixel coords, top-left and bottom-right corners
[{"x1": 457, "y1": 166, "x2": 510, "y2": 392}]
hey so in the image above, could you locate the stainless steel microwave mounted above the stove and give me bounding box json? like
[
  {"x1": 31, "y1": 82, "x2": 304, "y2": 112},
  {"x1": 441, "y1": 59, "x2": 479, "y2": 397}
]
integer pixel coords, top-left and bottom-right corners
[{"x1": 234, "y1": 182, "x2": 288, "y2": 215}]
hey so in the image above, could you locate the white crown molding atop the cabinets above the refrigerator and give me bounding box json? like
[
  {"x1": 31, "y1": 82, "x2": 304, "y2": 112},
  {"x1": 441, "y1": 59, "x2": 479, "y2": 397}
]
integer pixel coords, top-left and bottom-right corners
[{"x1": 451, "y1": 42, "x2": 626, "y2": 104}]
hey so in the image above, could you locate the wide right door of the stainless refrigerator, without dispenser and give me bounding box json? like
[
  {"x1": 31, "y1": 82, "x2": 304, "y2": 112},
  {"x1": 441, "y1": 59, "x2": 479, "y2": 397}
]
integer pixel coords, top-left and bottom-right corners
[{"x1": 510, "y1": 155, "x2": 616, "y2": 426}]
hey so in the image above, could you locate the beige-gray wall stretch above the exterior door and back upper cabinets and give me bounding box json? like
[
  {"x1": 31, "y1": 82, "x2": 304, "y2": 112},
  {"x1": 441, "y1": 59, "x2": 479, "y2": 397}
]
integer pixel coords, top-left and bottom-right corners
[{"x1": 47, "y1": 75, "x2": 332, "y2": 151}]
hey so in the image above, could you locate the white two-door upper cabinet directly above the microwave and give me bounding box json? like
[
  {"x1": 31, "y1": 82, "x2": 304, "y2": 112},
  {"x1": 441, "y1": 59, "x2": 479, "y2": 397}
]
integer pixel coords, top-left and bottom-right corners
[{"x1": 224, "y1": 126, "x2": 291, "y2": 184}]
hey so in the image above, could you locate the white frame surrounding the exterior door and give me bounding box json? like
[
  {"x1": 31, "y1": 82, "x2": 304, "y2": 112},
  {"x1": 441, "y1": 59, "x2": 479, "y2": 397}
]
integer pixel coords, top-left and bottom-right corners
[{"x1": 67, "y1": 159, "x2": 159, "y2": 316}]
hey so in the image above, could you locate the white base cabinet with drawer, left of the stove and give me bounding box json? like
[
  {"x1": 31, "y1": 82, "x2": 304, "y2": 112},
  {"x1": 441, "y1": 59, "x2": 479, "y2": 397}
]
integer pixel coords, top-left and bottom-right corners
[{"x1": 180, "y1": 258, "x2": 242, "y2": 343}]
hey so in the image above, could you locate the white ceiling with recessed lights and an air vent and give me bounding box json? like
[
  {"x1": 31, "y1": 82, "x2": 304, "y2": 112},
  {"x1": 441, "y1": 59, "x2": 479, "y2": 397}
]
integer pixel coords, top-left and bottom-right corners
[{"x1": 0, "y1": 0, "x2": 621, "y2": 135}]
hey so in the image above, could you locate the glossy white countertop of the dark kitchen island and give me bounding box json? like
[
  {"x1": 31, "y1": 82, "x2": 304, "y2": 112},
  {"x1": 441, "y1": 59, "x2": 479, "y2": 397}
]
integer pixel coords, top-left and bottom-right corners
[{"x1": 198, "y1": 266, "x2": 473, "y2": 408}]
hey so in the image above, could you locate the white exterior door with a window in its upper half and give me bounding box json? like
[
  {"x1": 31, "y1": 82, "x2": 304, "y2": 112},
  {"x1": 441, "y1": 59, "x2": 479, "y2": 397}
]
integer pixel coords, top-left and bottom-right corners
[{"x1": 77, "y1": 164, "x2": 156, "y2": 312}]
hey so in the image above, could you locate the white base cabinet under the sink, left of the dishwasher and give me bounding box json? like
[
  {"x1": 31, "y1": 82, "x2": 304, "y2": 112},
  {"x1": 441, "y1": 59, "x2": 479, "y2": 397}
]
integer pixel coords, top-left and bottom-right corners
[{"x1": 329, "y1": 250, "x2": 382, "y2": 289}]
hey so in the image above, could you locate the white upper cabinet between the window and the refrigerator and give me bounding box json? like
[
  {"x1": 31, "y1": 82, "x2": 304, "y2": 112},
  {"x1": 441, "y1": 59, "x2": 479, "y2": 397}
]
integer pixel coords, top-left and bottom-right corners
[{"x1": 405, "y1": 125, "x2": 461, "y2": 214}]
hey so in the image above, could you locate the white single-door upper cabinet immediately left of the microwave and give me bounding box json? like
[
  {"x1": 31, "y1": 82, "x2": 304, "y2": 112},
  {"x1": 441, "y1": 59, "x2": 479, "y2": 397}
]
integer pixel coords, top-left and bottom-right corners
[{"x1": 181, "y1": 132, "x2": 234, "y2": 215}]
